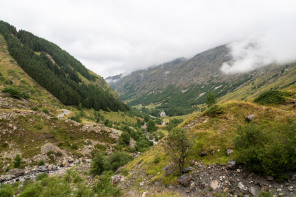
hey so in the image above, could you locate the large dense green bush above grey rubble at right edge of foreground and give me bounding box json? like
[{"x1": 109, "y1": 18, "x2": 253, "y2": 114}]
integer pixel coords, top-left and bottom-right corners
[{"x1": 234, "y1": 122, "x2": 296, "y2": 180}]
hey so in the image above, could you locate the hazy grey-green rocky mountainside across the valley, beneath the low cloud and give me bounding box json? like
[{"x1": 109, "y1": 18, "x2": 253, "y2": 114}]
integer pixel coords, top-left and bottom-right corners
[{"x1": 110, "y1": 46, "x2": 296, "y2": 115}]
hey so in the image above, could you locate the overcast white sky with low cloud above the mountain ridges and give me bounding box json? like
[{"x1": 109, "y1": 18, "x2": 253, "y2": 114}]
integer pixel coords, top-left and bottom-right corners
[{"x1": 0, "y1": 0, "x2": 296, "y2": 77}]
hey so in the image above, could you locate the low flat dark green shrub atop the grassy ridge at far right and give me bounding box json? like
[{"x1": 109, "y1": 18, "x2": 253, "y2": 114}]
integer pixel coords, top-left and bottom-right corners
[{"x1": 254, "y1": 90, "x2": 290, "y2": 105}]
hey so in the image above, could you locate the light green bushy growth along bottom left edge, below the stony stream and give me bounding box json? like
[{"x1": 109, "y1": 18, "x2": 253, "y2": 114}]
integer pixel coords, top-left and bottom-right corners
[{"x1": 0, "y1": 170, "x2": 122, "y2": 197}]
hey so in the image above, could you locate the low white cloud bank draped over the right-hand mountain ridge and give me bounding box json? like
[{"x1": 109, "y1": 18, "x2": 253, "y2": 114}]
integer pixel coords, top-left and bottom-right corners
[{"x1": 221, "y1": 21, "x2": 296, "y2": 74}]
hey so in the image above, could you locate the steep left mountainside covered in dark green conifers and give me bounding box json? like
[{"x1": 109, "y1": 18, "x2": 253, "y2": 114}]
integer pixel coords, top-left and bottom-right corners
[{"x1": 0, "y1": 21, "x2": 127, "y2": 111}]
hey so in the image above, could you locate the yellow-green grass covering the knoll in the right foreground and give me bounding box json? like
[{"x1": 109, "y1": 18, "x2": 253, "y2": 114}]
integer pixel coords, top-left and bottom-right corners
[{"x1": 122, "y1": 90, "x2": 296, "y2": 195}]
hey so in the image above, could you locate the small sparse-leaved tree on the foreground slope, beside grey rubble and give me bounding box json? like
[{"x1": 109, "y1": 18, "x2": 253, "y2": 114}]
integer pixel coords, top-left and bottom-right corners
[{"x1": 166, "y1": 128, "x2": 191, "y2": 173}]
